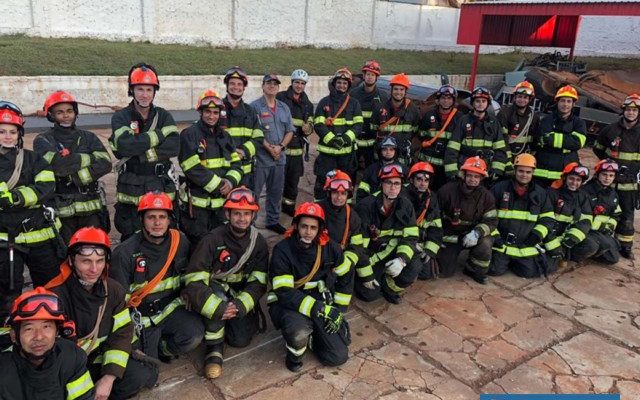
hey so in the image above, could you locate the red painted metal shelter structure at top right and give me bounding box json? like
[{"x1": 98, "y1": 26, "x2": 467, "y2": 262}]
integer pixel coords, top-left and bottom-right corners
[{"x1": 457, "y1": 0, "x2": 640, "y2": 89}]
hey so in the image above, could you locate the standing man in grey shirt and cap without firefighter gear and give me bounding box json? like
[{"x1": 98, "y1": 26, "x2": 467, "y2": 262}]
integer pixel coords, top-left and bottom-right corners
[{"x1": 251, "y1": 74, "x2": 295, "y2": 234}]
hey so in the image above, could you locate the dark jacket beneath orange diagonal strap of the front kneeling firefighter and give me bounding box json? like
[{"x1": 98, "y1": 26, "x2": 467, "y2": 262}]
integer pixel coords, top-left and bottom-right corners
[{"x1": 109, "y1": 231, "x2": 189, "y2": 328}]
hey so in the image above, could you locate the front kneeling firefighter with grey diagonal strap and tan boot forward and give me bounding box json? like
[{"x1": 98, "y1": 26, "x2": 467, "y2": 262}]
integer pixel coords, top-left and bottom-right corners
[{"x1": 183, "y1": 186, "x2": 269, "y2": 379}]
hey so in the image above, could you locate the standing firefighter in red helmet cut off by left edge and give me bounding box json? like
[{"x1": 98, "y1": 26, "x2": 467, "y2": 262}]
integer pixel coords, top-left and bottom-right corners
[{"x1": 0, "y1": 101, "x2": 62, "y2": 320}]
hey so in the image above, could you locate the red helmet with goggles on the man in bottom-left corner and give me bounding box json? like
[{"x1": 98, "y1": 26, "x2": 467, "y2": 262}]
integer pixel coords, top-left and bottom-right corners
[{"x1": 9, "y1": 287, "x2": 66, "y2": 323}]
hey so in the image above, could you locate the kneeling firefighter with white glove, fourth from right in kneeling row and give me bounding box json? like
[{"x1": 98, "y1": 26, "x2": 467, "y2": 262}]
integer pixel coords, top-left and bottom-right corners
[{"x1": 438, "y1": 156, "x2": 498, "y2": 285}]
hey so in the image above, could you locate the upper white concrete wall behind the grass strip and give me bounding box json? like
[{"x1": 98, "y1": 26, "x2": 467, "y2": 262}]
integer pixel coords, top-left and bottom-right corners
[{"x1": 0, "y1": 0, "x2": 640, "y2": 57}]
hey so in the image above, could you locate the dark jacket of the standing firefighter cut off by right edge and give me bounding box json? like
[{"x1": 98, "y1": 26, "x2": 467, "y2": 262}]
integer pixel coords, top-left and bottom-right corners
[{"x1": 593, "y1": 118, "x2": 640, "y2": 192}]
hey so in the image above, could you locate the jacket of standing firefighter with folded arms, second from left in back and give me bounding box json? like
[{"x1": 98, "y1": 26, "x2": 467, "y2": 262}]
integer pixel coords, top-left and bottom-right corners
[{"x1": 33, "y1": 124, "x2": 112, "y2": 218}]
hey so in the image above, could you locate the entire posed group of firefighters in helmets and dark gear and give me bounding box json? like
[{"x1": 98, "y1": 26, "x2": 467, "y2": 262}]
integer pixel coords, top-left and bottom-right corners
[{"x1": 0, "y1": 60, "x2": 640, "y2": 399}]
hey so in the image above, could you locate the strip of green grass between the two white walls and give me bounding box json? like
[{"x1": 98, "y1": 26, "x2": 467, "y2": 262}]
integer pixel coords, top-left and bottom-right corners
[{"x1": 0, "y1": 35, "x2": 637, "y2": 76}]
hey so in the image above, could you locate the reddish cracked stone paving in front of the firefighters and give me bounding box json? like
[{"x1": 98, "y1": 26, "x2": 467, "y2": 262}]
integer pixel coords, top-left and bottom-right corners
[{"x1": 25, "y1": 131, "x2": 640, "y2": 400}]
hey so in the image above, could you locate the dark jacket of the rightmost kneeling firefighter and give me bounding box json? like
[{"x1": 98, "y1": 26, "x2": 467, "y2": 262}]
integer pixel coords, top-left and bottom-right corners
[{"x1": 580, "y1": 177, "x2": 622, "y2": 234}]
